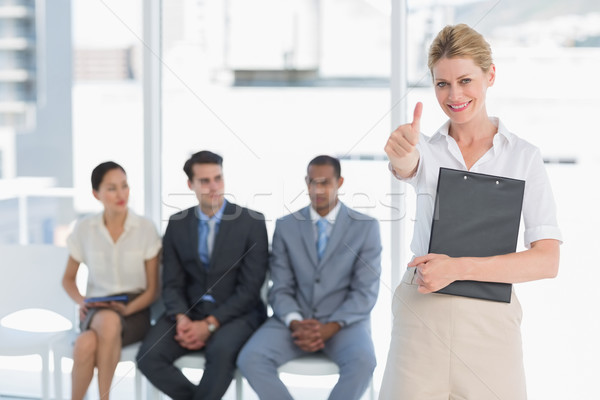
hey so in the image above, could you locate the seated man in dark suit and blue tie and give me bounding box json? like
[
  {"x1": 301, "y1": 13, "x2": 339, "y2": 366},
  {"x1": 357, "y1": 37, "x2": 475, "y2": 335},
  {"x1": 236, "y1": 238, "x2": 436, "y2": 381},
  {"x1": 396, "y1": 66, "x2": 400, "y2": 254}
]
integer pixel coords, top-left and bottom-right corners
[{"x1": 137, "y1": 151, "x2": 268, "y2": 400}]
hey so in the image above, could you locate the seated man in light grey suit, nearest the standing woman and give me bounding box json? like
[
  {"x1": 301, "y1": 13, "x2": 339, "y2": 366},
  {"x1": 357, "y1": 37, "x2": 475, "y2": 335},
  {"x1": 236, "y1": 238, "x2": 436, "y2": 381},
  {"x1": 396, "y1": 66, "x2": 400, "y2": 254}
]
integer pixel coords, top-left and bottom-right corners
[{"x1": 238, "y1": 156, "x2": 381, "y2": 400}]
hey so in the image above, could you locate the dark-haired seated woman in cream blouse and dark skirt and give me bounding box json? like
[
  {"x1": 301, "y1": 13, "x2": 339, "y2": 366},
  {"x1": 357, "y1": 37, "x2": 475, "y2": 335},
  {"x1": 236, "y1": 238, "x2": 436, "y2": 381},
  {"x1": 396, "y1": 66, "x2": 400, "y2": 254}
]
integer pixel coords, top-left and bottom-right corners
[{"x1": 62, "y1": 161, "x2": 161, "y2": 400}]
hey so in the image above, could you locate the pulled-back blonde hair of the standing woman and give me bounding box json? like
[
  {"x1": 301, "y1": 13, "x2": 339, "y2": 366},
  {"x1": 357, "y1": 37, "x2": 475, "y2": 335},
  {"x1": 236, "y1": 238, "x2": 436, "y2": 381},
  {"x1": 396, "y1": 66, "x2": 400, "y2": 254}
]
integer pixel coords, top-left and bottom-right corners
[{"x1": 427, "y1": 24, "x2": 493, "y2": 77}]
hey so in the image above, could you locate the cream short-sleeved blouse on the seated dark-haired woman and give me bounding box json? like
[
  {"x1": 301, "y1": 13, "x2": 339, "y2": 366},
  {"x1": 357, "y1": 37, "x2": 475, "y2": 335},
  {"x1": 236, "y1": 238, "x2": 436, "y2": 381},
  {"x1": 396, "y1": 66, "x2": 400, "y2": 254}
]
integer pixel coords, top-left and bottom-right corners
[{"x1": 67, "y1": 210, "x2": 161, "y2": 297}]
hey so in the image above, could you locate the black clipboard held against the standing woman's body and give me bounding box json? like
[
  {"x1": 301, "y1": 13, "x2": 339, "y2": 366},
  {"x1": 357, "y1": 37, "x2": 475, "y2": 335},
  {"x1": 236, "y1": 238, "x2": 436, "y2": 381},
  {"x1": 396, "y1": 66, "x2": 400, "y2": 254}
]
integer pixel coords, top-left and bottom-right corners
[{"x1": 429, "y1": 168, "x2": 525, "y2": 303}]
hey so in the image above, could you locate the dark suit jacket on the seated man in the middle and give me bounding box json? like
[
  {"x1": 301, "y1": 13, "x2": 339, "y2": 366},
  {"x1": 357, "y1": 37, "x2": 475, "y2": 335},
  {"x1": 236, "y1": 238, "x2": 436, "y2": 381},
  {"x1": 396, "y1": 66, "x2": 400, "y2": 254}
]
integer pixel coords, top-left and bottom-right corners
[{"x1": 162, "y1": 202, "x2": 269, "y2": 326}]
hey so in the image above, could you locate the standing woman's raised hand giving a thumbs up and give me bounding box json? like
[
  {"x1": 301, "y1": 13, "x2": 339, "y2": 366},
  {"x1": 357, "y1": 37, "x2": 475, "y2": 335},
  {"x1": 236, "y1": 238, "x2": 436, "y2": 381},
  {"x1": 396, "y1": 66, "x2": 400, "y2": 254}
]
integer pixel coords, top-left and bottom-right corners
[{"x1": 384, "y1": 102, "x2": 423, "y2": 178}]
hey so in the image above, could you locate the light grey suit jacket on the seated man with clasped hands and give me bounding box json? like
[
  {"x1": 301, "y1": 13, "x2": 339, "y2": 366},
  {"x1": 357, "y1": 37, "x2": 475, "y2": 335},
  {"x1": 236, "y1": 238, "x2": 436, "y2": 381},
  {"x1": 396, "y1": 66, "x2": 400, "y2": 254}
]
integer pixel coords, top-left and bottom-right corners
[{"x1": 269, "y1": 203, "x2": 381, "y2": 325}]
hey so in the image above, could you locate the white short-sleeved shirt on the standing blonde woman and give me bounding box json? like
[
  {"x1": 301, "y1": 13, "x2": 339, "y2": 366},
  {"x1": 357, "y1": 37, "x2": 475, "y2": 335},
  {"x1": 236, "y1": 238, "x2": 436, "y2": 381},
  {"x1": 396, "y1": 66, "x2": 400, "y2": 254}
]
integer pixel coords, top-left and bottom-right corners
[{"x1": 390, "y1": 118, "x2": 562, "y2": 257}]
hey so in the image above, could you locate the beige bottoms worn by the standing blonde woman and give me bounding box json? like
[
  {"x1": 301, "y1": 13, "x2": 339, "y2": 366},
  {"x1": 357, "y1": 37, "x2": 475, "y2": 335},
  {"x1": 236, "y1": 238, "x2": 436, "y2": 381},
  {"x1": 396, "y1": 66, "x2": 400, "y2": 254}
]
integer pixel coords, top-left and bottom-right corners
[{"x1": 379, "y1": 268, "x2": 527, "y2": 400}]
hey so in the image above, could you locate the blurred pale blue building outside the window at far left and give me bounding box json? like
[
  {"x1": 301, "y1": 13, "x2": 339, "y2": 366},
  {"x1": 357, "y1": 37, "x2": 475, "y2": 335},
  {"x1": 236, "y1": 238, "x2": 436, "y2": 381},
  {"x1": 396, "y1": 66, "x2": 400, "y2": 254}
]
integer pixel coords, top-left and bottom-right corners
[{"x1": 0, "y1": 0, "x2": 75, "y2": 244}]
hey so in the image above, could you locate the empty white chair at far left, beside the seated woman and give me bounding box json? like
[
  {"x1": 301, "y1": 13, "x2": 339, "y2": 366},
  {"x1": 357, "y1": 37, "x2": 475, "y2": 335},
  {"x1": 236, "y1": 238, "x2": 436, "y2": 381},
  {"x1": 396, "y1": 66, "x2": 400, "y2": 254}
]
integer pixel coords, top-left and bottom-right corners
[{"x1": 0, "y1": 245, "x2": 75, "y2": 400}]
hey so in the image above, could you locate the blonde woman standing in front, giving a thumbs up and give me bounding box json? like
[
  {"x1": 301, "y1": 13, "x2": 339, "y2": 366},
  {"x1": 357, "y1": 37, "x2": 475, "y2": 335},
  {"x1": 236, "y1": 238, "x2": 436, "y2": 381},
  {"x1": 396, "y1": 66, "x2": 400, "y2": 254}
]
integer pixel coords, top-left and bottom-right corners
[{"x1": 380, "y1": 24, "x2": 561, "y2": 400}]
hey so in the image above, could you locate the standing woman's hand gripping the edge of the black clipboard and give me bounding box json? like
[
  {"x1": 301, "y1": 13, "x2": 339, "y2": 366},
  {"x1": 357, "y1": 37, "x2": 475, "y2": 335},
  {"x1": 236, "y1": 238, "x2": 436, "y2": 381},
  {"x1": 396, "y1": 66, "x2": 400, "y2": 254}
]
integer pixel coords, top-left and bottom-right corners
[{"x1": 408, "y1": 253, "x2": 458, "y2": 293}]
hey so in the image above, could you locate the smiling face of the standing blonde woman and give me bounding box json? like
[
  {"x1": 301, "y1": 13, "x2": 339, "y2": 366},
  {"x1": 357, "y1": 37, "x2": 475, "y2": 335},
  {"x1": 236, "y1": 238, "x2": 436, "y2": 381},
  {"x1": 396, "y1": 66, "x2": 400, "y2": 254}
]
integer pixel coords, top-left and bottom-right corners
[{"x1": 432, "y1": 58, "x2": 496, "y2": 124}]
